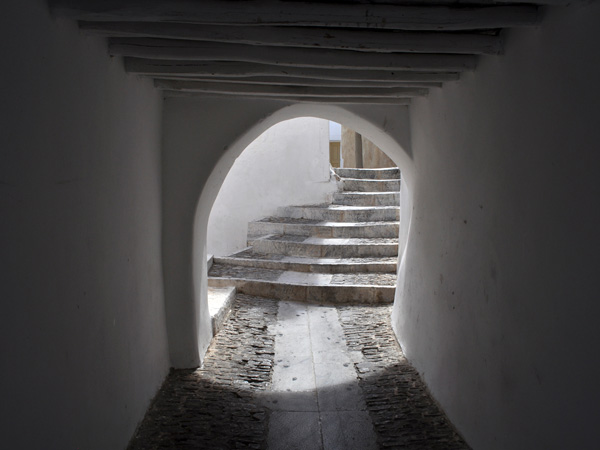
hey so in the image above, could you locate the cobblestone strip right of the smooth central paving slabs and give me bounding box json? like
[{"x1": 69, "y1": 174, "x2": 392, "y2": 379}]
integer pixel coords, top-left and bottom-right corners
[{"x1": 338, "y1": 306, "x2": 469, "y2": 450}]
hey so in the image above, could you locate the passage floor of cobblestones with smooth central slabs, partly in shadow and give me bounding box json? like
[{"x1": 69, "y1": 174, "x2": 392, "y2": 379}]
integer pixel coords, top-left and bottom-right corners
[{"x1": 129, "y1": 295, "x2": 468, "y2": 450}]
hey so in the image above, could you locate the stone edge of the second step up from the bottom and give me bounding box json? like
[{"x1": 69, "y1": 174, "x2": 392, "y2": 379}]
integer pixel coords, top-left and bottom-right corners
[{"x1": 215, "y1": 253, "x2": 398, "y2": 274}]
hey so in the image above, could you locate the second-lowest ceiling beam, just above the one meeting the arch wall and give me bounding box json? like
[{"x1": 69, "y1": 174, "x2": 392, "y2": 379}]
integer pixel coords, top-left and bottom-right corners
[{"x1": 154, "y1": 79, "x2": 428, "y2": 98}]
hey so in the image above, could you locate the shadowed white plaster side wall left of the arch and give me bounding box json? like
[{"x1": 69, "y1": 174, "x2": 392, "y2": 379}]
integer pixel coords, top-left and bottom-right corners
[{"x1": 0, "y1": 0, "x2": 169, "y2": 450}]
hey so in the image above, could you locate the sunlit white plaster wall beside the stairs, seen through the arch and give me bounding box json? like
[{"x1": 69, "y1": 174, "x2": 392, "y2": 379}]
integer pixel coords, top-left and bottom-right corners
[{"x1": 207, "y1": 117, "x2": 337, "y2": 256}]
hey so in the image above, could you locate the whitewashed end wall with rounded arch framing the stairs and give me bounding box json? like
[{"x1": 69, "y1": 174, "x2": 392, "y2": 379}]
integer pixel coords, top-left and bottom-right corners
[{"x1": 163, "y1": 98, "x2": 412, "y2": 367}]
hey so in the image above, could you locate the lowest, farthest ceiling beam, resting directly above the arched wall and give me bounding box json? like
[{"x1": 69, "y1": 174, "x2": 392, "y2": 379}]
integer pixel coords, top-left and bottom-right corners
[{"x1": 163, "y1": 89, "x2": 410, "y2": 106}]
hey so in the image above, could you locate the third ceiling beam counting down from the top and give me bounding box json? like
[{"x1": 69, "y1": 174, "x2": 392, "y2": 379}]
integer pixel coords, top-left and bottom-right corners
[{"x1": 109, "y1": 38, "x2": 478, "y2": 72}]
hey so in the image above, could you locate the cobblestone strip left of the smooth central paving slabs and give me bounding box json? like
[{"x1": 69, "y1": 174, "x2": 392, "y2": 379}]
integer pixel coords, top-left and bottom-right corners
[{"x1": 128, "y1": 295, "x2": 277, "y2": 450}]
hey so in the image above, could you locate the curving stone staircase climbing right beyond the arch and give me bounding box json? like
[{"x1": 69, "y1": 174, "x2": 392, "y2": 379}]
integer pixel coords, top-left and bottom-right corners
[{"x1": 208, "y1": 167, "x2": 400, "y2": 326}]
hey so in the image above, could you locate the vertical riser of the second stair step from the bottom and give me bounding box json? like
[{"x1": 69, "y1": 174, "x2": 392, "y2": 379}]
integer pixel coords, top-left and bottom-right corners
[{"x1": 215, "y1": 257, "x2": 398, "y2": 273}]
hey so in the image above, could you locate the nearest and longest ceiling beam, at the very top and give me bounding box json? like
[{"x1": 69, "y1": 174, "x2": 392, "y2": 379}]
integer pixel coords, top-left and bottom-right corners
[{"x1": 49, "y1": 0, "x2": 538, "y2": 31}]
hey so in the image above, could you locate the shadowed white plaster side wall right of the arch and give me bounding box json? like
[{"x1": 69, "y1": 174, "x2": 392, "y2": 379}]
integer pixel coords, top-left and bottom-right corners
[{"x1": 393, "y1": 3, "x2": 600, "y2": 450}]
